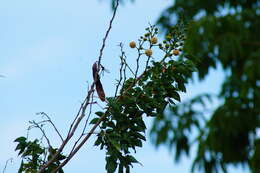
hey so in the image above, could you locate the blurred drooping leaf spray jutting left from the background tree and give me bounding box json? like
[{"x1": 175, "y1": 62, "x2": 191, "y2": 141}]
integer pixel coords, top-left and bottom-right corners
[{"x1": 151, "y1": 94, "x2": 213, "y2": 161}]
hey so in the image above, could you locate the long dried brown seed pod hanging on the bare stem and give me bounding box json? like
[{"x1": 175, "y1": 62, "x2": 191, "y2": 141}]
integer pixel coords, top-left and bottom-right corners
[{"x1": 92, "y1": 62, "x2": 106, "y2": 101}]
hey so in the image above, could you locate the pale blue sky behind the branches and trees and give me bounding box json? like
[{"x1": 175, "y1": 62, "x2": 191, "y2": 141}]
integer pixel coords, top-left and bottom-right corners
[{"x1": 0, "y1": 0, "x2": 248, "y2": 173}]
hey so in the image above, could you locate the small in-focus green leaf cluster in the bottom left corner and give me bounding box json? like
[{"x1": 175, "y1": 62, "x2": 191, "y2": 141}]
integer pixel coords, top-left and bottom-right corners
[{"x1": 15, "y1": 137, "x2": 66, "y2": 173}]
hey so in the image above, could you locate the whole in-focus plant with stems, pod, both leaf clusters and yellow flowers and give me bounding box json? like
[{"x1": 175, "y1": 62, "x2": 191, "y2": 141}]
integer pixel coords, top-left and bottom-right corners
[{"x1": 15, "y1": 23, "x2": 197, "y2": 173}]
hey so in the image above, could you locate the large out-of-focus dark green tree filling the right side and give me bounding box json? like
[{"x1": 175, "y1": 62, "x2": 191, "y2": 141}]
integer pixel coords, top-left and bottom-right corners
[{"x1": 149, "y1": 0, "x2": 260, "y2": 173}]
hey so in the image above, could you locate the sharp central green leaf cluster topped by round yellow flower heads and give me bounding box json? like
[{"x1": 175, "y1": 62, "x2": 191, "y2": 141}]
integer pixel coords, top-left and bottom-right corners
[{"x1": 91, "y1": 25, "x2": 195, "y2": 173}]
